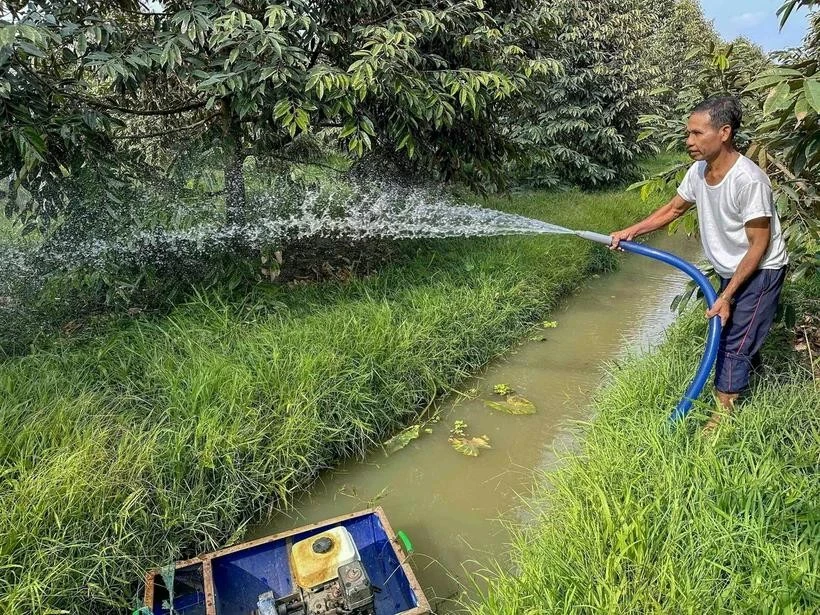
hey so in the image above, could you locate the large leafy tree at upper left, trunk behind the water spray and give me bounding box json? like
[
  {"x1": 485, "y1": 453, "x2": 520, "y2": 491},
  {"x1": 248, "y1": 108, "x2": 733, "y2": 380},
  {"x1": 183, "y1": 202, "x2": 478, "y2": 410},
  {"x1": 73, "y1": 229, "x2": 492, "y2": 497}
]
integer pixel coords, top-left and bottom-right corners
[{"x1": 0, "y1": 0, "x2": 557, "y2": 231}]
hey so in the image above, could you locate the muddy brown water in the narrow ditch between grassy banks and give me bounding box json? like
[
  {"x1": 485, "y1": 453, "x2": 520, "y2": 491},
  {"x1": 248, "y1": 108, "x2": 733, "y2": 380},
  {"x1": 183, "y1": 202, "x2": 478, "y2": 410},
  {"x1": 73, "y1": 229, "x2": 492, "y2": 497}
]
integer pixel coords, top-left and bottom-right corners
[{"x1": 248, "y1": 234, "x2": 702, "y2": 613}]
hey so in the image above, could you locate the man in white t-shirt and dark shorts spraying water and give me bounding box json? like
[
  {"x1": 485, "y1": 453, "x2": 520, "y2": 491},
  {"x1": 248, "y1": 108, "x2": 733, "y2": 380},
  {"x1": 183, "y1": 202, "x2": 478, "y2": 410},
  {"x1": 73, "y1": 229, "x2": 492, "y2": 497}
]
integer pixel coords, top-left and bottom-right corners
[{"x1": 612, "y1": 97, "x2": 789, "y2": 431}]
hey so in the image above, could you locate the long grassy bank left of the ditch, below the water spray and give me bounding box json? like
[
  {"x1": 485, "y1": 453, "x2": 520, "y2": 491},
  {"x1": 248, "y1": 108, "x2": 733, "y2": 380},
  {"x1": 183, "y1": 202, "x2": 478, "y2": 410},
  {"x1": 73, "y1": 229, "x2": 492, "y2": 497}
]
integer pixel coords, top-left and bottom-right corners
[{"x1": 0, "y1": 183, "x2": 651, "y2": 612}]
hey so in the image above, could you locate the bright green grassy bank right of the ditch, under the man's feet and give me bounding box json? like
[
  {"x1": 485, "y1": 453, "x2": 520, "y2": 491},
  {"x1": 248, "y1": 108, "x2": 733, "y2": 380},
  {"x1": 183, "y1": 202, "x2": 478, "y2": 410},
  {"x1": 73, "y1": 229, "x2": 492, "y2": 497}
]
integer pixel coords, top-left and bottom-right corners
[{"x1": 470, "y1": 283, "x2": 820, "y2": 615}]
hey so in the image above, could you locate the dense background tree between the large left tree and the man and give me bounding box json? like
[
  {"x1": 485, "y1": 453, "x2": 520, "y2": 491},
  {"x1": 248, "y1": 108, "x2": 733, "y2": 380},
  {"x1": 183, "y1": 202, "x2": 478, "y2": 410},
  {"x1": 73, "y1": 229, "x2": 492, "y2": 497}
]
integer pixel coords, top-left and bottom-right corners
[{"x1": 511, "y1": 0, "x2": 654, "y2": 186}]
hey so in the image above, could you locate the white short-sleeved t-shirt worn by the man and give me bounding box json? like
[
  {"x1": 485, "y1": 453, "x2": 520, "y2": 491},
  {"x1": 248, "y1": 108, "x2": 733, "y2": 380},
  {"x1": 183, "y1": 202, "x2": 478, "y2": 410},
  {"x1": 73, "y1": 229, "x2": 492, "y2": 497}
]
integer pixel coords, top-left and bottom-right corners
[{"x1": 678, "y1": 156, "x2": 789, "y2": 278}]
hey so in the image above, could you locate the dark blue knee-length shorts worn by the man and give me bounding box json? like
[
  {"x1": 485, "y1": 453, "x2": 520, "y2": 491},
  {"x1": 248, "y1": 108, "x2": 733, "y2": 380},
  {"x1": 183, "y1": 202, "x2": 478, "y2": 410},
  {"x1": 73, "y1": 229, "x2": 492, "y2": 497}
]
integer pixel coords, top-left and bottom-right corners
[{"x1": 715, "y1": 267, "x2": 786, "y2": 393}]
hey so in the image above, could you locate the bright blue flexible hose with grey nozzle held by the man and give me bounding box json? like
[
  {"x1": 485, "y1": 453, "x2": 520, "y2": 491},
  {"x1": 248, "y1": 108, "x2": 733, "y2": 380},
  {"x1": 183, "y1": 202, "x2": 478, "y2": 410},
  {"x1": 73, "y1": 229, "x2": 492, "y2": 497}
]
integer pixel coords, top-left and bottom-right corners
[{"x1": 576, "y1": 231, "x2": 721, "y2": 421}]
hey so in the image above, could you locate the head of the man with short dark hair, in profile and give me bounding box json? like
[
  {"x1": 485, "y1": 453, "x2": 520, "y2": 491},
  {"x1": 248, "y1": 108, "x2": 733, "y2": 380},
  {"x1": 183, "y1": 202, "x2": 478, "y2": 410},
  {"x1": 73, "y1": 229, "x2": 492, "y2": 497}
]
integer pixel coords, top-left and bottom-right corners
[{"x1": 686, "y1": 96, "x2": 743, "y2": 161}]
